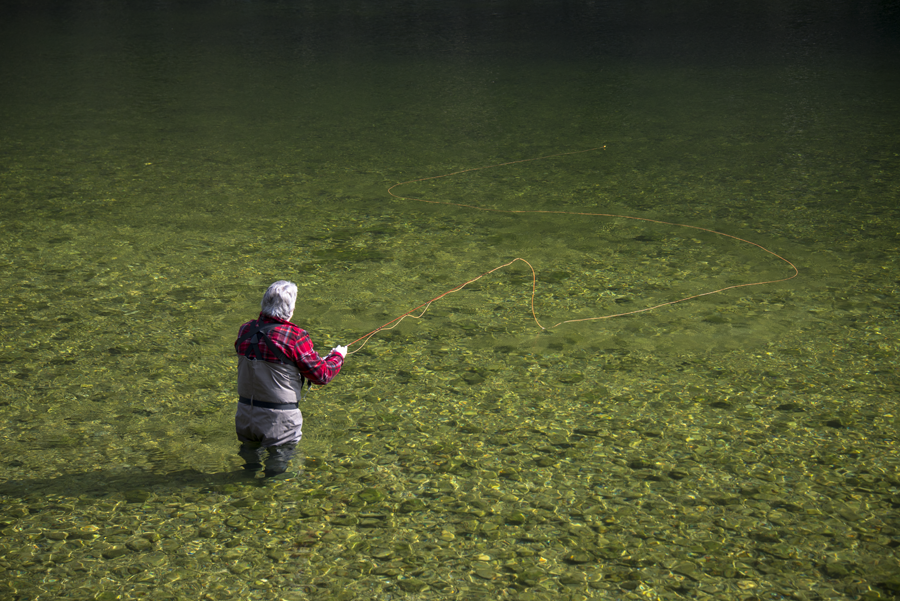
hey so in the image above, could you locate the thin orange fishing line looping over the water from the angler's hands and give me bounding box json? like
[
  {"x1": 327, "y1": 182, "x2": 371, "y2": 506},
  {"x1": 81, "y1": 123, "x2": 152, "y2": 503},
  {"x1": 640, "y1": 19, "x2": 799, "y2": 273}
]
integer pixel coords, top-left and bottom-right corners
[{"x1": 347, "y1": 146, "x2": 800, "y2": 355}]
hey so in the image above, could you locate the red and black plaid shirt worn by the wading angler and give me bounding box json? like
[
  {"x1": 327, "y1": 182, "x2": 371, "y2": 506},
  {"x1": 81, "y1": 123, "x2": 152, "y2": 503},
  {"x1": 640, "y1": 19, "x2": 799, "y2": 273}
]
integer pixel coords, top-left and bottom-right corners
[{"x1": 234, "y1": 313, "x2": 344, "y2": 386}]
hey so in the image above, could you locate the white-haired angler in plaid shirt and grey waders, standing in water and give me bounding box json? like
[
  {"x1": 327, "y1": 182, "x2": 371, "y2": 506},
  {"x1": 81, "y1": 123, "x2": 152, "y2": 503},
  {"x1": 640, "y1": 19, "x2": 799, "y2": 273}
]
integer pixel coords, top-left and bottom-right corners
[{"x1": 234, "y1": 280, "x2": 347, "y2": 478}]
